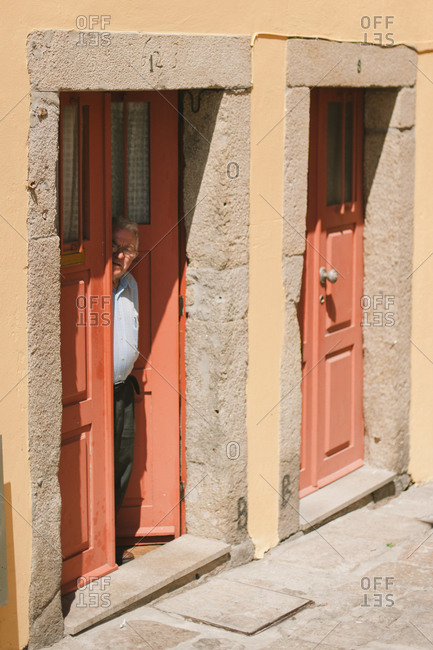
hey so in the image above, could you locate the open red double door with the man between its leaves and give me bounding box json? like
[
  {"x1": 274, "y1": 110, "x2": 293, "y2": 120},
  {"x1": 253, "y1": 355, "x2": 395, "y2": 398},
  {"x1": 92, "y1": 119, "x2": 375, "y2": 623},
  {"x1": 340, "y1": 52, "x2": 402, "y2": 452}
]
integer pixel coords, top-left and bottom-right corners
[{"x1": 59, "y1": 91, "x2": 181, "y2": 592}]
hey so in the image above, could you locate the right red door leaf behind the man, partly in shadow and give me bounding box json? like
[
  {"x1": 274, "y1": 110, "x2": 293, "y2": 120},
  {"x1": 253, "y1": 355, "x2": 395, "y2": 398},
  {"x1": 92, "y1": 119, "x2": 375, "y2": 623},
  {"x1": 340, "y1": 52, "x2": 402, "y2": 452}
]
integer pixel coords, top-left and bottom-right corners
[{"x1": 106, "y1": 91, "x2": 180, "y2": 544}]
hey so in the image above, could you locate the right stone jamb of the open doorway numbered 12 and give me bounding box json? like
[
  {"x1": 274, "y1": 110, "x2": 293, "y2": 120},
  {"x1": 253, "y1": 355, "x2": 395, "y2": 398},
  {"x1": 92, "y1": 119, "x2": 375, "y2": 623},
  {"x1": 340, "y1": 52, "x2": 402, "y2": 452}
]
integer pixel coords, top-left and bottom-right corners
[{"x1": 183, "y1": 90, "x2": 252, "y2": 555}]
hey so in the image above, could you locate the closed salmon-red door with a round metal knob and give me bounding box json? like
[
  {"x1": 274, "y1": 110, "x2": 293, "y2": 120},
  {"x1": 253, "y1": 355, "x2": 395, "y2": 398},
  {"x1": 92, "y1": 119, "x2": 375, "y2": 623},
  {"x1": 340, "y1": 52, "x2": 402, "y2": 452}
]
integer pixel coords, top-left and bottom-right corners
[{"x1": 300, "y1": 89, "x2": 364, "y2": 496}]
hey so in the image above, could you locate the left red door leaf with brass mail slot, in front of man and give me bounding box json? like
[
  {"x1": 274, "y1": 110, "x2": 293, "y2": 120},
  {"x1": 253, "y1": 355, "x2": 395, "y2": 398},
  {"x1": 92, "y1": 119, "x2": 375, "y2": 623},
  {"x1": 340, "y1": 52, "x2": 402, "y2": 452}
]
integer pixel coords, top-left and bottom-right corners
[{"x1": 59, "y1": 93, "x2": 116, "y2": 592}]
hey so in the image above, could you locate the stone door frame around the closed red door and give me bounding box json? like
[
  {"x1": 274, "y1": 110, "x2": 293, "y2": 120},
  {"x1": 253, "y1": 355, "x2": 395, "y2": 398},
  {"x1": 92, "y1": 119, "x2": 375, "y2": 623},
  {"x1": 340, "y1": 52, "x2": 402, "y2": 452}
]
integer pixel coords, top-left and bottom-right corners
[{"x1": 279, "y1": 38, "x2": 417, "y2": 539}]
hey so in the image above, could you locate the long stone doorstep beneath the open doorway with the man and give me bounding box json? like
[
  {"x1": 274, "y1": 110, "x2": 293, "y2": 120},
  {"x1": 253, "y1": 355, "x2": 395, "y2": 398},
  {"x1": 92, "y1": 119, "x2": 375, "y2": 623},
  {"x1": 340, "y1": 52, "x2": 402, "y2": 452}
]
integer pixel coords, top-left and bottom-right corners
[{"x1": 64, "y1": 534, "x2": 230, "y2": 635}]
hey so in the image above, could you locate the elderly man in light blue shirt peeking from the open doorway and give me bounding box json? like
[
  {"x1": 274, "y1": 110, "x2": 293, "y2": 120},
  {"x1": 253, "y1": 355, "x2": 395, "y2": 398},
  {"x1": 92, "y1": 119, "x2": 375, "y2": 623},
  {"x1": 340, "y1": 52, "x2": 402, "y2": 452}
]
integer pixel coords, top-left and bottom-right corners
[{"x1": 112, "y1": 220, "x2": 138, "y2": 564}]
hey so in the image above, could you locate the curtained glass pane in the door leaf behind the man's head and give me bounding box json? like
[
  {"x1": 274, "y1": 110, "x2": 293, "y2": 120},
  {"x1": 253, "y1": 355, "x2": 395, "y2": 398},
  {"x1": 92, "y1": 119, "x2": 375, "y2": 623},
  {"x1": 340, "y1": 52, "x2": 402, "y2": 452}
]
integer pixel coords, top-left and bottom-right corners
[{"x1": 111, "y1": 101, "x2": 150, "y2": 224}]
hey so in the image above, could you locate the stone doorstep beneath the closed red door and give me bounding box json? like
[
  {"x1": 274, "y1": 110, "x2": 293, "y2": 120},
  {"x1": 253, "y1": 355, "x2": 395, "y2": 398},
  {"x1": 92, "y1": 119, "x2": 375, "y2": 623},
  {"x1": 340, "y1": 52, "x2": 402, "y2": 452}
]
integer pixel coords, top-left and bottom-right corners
[{"x1": 299, "y1": 465, "x2": 396, "y2": 532}]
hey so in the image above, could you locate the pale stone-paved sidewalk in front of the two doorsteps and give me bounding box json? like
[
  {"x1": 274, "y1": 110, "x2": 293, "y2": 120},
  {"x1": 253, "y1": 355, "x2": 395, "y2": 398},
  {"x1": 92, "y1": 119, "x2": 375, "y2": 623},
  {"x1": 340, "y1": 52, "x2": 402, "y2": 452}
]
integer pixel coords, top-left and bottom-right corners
[{"x1": 44, "y1": 484, "x2": 433, "y2": 650}]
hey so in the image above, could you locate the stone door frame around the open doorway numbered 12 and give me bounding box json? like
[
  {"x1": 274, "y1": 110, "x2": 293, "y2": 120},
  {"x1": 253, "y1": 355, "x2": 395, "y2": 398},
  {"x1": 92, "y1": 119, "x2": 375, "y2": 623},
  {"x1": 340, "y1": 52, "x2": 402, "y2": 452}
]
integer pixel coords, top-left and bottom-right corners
[{"x1": 27, "y1": 30, "x2": 251, "y2": 646}]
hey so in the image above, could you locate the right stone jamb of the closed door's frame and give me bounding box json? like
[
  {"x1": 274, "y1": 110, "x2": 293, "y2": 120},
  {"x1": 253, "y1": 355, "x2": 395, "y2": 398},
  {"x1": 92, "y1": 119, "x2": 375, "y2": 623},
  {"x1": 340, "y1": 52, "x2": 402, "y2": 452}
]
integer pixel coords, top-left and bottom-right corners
[{"x1": 363, "y1": 87, "x2": 415, "y2": 474}]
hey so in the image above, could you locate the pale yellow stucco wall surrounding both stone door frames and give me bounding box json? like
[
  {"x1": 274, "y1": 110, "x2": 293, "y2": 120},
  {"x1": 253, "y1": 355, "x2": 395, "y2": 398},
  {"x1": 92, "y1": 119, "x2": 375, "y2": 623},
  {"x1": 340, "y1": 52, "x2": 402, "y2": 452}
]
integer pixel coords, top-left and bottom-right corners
[{"x1": 0, "y1": 0, "x2": 433, "y2": 648}]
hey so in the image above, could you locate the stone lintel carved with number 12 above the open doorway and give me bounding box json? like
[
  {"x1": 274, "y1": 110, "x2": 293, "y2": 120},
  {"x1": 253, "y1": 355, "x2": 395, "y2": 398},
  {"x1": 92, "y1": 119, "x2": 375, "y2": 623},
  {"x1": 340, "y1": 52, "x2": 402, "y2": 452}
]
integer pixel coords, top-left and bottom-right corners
[{"x1": 27, "y1": 30, "x2": 251, "y2": 91}]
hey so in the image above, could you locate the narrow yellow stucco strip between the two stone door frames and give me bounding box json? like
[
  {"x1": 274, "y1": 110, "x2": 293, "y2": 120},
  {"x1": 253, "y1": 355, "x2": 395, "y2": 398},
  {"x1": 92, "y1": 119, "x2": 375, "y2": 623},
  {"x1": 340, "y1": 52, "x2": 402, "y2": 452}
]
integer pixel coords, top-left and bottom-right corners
[{"x1": 247, "y1": 37, "x2": 286, "y2": 557}]
